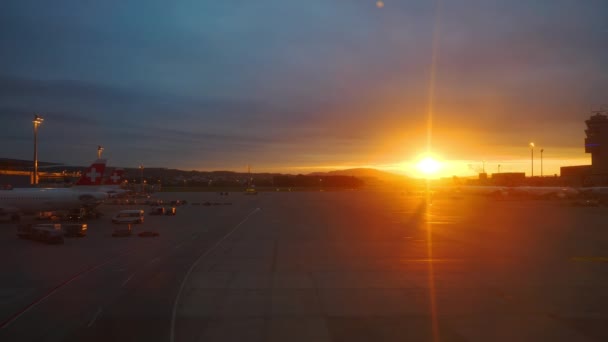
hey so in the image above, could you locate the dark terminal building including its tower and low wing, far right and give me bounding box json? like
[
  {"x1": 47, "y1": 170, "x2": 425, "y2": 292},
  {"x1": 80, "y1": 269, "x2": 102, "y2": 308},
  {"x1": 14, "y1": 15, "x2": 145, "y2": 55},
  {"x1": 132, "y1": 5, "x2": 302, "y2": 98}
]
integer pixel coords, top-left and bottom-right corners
[{"x1": 560, "y1": 109, "x2": 608, "y2": 186}]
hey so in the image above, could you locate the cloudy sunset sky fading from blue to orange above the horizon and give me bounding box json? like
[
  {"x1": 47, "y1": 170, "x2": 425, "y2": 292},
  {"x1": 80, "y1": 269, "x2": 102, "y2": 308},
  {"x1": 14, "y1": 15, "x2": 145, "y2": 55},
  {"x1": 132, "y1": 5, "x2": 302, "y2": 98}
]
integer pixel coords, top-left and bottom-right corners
[{"x1": 0, "y1": 0, "x2": 608, "y2": 176}]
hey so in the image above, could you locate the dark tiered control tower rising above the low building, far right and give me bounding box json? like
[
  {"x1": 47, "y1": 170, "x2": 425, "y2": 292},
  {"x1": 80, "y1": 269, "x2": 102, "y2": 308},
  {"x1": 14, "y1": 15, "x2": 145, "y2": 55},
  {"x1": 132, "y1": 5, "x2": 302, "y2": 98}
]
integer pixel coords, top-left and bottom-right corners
[{"x1": 585, "y1": 108, "x2": 608, "y2": 175}]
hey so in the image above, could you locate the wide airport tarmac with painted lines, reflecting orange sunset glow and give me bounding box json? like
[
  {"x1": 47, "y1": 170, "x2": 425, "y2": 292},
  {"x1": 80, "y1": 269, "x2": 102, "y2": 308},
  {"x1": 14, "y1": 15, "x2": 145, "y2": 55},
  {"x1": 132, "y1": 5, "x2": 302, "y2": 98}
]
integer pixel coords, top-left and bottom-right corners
[{"x1": 0, "y1": 191, "x2": 608, "y2": 342}]
